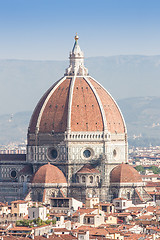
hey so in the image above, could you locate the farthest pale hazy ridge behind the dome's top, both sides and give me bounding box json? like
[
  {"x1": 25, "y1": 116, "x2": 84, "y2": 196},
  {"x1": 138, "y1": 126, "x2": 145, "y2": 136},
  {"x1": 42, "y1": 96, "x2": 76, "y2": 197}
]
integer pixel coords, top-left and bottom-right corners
[{"x1": 0, "y1": 55, "x2": 160, "y2": 115}]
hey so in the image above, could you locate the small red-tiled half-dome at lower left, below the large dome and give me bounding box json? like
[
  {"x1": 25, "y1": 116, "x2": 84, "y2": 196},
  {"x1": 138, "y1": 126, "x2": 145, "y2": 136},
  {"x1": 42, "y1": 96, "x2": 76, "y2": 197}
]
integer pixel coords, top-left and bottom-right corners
[{"x1": 32, "y1": 163, "x2": 67, "y2": 183}]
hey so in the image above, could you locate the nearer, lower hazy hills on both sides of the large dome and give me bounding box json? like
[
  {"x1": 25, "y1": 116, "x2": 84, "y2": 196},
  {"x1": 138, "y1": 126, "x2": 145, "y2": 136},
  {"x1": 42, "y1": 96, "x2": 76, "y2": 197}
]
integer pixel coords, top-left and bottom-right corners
[{"x1": 0, "y1": 97, "x2": 160, "y2": 146}]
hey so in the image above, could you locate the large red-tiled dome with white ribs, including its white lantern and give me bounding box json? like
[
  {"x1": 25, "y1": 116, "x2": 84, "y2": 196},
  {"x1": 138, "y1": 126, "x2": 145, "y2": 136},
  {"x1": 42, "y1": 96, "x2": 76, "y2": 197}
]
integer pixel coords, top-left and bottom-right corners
[{"x1": 29, "y1": 36, "x2": 126, "y2": 134}]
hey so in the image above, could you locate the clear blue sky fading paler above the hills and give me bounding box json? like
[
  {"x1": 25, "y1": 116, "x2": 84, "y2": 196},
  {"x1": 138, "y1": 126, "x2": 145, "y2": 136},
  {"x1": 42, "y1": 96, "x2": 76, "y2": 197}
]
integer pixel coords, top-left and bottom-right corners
[{"x1": 0, "y1": 0, "x2": 160, "y2": 60}]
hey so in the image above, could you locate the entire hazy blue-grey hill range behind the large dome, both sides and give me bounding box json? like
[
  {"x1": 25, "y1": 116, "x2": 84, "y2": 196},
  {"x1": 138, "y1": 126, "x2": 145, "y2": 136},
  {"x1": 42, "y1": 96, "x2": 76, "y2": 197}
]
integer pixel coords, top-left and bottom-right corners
[{"x1": 0, "y1": 56, "x2": 160, "y2": 145}]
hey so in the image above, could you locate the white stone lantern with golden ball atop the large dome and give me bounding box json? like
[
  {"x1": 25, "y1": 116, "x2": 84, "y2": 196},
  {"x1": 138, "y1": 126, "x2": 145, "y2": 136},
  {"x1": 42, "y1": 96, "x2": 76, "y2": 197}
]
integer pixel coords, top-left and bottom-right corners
[{"x1": 65, "y1": 34, "x2": 88, "y2": 76}]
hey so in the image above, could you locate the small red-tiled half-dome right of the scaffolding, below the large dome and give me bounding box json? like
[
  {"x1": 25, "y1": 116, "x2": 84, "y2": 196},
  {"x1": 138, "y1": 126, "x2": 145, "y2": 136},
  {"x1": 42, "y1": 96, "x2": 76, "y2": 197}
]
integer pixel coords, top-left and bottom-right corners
[{"x1": 110, "y1": 163, "x2": 142, "y2": 183}]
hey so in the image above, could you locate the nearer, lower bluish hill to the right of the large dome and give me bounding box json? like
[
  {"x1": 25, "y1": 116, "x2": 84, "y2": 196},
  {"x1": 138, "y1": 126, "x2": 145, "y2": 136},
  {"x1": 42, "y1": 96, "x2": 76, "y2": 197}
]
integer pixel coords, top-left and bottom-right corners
[{"x1": 118, "y1": 97, "x2": 160, "y2": 146}]
